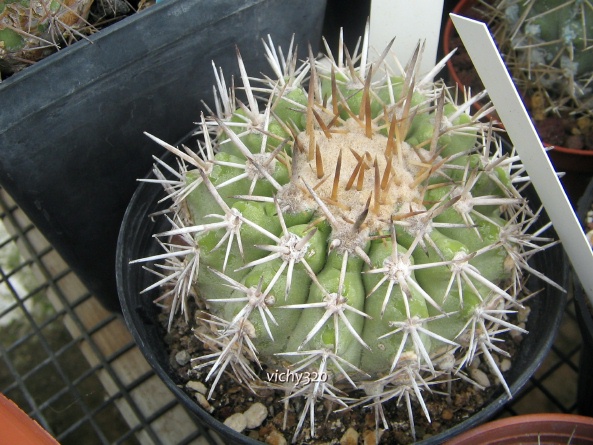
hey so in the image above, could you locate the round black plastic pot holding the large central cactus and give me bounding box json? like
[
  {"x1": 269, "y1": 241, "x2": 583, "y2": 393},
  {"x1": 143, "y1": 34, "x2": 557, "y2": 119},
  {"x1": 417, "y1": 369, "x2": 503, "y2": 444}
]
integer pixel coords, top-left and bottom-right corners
[{"x1": 117, "y1": 155, "x2": 566, "y2": 444}]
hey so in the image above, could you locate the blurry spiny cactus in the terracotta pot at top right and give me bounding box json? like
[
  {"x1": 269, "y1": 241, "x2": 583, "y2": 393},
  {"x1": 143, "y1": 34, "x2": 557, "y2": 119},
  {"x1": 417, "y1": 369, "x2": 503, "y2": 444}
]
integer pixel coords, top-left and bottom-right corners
[{"x1": 487, "y1": 0, "x2": 593, "y2": 120}]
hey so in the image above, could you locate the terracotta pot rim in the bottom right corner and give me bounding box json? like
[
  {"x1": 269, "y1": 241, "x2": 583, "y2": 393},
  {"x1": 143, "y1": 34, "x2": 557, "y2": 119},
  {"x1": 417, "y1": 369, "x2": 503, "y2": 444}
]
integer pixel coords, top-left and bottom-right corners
[{"x1": 446, "y1": 413, "x2": 593, "y2": 445}]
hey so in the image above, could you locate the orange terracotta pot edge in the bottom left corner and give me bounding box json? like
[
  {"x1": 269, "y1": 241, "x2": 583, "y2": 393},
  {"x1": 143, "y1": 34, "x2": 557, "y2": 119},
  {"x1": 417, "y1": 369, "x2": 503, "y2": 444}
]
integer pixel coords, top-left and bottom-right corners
[{"x1": 0, "y1": 394, "x2": 59, "y2": 445}]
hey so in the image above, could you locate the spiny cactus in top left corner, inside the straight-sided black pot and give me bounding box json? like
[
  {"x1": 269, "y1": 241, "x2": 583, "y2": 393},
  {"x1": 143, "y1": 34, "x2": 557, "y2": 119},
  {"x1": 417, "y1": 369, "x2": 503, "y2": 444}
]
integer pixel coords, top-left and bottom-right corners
[{"x1": 0, "y1": 0, "x2": 95, "y2": 74}]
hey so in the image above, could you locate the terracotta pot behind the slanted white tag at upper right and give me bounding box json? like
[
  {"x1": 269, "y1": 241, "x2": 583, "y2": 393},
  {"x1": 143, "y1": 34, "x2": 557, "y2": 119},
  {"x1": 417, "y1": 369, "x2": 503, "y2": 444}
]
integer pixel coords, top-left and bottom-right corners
[{"x1": 442, "y1": 0, "x2": 593, "y2": 202}]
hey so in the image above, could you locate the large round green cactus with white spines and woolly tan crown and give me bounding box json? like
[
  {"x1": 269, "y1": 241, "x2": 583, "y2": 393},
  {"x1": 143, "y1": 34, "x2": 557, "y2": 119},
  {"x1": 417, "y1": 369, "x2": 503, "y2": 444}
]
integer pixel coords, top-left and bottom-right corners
[{"x1": 134, "y1": 26, "x2": 553, "y2": 440}]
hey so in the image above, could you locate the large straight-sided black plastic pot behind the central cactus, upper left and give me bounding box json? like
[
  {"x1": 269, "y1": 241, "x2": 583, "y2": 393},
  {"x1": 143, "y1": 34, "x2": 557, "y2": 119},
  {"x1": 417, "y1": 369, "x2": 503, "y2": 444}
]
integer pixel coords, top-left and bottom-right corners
[{"x1": 0, "y1": 0, "x2": 325, "y2": 310}]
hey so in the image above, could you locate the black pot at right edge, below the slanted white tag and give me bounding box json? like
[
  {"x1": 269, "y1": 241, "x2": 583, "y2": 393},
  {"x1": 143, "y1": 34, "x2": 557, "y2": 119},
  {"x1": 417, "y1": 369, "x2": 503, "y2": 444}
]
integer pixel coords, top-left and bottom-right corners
[{"x1": 572, "y1": 181, "x2": 593, "y2": 416}]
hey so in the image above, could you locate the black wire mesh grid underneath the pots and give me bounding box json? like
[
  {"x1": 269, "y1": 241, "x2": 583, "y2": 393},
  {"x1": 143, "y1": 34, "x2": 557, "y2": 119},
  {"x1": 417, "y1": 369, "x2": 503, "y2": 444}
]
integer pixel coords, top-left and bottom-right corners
[{"x1": 0, "y1": 189, "x2": 581, "y2": 445}]
